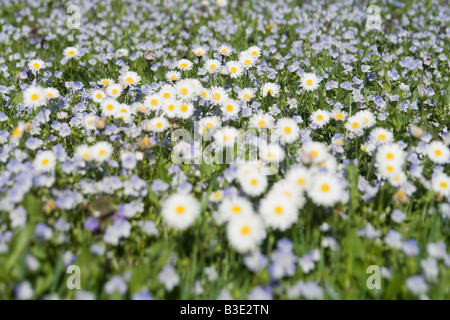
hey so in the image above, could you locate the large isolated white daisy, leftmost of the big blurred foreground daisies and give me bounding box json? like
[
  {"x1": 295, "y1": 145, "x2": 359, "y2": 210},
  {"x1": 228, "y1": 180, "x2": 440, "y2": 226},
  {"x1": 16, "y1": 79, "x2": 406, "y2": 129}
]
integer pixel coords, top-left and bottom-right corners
[{"x1": 161, "y1": 193, "x2": 200, "y2": 230}]
